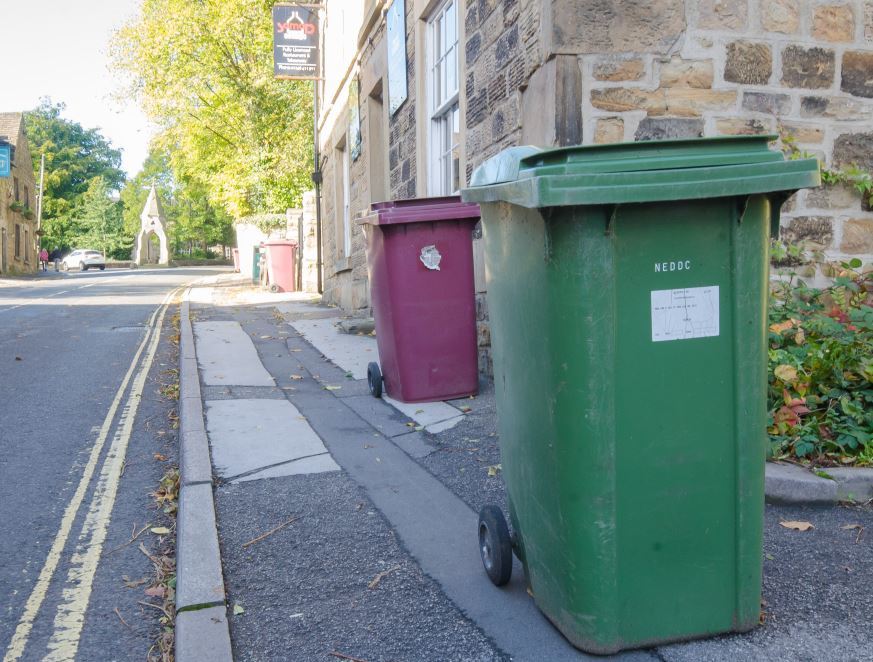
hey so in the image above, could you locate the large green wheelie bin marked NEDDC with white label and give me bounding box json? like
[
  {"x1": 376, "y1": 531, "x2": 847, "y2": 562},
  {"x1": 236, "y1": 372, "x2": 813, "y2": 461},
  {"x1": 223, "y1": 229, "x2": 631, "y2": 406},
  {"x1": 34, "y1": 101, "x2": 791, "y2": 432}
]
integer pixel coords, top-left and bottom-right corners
[{"x1": 462, "y1": 136, "x2": 820, "y2": 654}]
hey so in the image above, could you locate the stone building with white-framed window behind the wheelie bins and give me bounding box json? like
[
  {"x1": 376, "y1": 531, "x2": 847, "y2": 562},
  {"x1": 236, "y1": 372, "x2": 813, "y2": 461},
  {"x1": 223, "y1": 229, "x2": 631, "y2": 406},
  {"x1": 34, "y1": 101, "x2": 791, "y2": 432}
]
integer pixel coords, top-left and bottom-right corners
[{"x1": 318, "y1": 0, "x2": 873, "y2": 374}]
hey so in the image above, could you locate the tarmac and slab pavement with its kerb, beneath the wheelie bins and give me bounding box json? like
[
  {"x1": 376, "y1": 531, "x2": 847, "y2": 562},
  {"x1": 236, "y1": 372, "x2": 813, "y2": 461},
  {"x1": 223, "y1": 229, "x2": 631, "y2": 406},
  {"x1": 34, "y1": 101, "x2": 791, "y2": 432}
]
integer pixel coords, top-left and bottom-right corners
[{"x1": 176, "y1": 276, "x2": 873, "y2": 662}]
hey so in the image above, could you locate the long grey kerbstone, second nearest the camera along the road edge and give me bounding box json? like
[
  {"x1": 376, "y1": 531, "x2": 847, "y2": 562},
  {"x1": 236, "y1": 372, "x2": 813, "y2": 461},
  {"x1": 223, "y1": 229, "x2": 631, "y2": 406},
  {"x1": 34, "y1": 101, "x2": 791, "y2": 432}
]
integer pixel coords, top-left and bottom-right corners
[{"x1": 176, "y1": 484, "x2": 224, "y2": 611}]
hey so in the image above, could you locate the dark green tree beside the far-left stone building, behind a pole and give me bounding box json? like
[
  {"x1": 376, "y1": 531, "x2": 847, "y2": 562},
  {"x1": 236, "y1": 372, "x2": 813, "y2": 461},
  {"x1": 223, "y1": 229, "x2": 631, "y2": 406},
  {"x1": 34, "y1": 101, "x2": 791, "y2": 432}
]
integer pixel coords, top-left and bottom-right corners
[{"x1": 24, "y1": 98, "x2": 125, "y2": 248}]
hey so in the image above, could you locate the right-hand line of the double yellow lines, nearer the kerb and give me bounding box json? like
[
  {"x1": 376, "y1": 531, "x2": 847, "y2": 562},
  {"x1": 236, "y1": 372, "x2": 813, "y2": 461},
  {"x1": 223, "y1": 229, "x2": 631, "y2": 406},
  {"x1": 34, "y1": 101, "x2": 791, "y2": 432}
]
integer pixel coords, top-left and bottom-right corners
[{"x1": 43, "y1": 300, "x2": 167, "y2": 662}]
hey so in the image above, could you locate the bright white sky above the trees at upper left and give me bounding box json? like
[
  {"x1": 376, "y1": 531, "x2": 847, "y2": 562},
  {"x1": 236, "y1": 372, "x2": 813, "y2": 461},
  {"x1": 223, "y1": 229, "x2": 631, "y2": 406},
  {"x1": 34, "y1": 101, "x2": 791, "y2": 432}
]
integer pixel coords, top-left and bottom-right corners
[{"x1": 0, "y1": 0, "x2": 154, "y2": 176}]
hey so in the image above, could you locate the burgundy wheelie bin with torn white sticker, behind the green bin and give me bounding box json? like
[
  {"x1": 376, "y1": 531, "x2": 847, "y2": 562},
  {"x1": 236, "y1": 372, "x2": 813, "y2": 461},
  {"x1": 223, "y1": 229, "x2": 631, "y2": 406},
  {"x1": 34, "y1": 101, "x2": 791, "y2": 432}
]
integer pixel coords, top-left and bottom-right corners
[{"x1": 358, "y1": 196, "x2": 479, "y2": 402}]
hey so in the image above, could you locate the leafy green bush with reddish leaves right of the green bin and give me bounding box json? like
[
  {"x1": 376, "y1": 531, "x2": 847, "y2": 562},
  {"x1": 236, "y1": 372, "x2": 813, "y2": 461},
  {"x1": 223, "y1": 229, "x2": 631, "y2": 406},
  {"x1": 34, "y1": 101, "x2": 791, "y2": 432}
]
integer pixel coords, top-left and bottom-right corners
[{"x1": 767, "y1": 259, "x2": 873, "y2": 465}]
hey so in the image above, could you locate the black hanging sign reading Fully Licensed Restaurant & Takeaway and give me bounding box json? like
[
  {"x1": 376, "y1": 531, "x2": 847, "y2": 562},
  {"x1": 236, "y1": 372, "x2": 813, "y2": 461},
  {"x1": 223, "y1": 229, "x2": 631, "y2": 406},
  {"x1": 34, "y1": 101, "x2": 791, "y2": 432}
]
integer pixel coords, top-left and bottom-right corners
[{"x1": 273, "y1": 5, "x2": 319, "y2": 80}]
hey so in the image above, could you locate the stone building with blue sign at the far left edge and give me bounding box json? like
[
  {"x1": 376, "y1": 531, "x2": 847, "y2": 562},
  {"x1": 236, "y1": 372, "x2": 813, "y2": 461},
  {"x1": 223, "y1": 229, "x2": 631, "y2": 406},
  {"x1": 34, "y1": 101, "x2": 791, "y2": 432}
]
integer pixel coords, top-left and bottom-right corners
[{"x1": 0, "y1": 113, "x2": 39, "y2": 276}]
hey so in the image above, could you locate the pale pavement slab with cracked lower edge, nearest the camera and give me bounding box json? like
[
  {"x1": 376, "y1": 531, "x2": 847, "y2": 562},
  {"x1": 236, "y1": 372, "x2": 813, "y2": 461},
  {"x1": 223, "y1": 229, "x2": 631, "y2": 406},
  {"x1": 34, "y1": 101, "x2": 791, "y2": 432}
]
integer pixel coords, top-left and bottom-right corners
[{"x1": 206, "y1": 399, "x2": 338, "y2": 479}]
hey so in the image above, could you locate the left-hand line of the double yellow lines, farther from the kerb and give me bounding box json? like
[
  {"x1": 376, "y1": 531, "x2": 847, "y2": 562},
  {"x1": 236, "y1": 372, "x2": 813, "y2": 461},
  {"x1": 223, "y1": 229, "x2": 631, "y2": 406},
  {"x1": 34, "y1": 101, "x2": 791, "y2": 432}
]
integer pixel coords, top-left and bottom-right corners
[{"x1": 0, "y1": 290, "x2": 175, "y2": 662}]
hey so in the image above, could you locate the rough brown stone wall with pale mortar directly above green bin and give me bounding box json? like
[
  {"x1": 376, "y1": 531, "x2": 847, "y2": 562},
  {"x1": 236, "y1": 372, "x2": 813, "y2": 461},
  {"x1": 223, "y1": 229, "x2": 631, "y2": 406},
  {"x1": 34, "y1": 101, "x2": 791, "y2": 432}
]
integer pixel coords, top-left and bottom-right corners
[{"x1": 579, "y1": 0, "x2": 873, "y2": 275}]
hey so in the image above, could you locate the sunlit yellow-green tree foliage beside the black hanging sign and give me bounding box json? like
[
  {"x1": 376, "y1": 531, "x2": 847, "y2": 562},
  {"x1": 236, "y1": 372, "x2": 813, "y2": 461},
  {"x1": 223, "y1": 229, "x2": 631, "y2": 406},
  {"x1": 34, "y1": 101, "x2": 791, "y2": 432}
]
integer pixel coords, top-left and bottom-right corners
[{"x1": 112, "y1": 0, "x2": 312, "y2": 217}]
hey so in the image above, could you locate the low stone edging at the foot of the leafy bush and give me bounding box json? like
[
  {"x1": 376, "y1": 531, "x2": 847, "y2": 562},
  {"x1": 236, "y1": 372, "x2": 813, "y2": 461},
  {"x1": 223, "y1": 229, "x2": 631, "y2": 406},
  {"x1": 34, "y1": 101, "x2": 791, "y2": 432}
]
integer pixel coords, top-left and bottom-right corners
[{"x1": 764, "y1": 462, "x2": 873, "y2": 505}]
